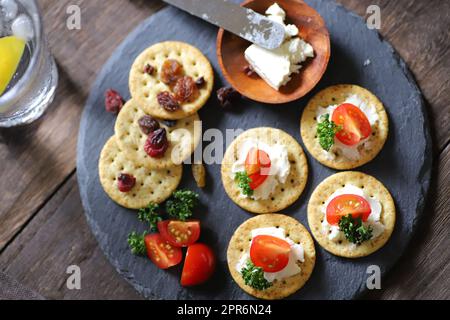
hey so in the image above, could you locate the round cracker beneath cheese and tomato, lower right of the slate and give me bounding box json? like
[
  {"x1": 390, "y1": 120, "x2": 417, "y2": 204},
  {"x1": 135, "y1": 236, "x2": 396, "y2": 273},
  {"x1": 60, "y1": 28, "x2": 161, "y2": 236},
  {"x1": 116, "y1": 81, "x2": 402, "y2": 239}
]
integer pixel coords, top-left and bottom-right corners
[{"x1": 308, "y1": 171, "x2": 395, "y2": 258}]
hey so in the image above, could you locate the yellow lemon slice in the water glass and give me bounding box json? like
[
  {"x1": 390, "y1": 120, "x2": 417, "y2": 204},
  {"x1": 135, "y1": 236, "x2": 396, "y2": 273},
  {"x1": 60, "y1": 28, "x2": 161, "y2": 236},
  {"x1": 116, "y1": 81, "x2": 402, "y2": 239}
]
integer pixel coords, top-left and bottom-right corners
[{"x1": 0, "y1": 36, "x2": 25, "y2": 95}]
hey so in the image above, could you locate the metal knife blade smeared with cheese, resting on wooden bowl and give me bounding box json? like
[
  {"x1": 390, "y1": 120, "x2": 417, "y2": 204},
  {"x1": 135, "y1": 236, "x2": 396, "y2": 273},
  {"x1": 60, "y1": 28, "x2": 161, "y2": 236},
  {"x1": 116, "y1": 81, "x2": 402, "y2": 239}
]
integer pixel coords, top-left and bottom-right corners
[{"x1": 164, "y1": 0, "x2": 285, "y2": 49}]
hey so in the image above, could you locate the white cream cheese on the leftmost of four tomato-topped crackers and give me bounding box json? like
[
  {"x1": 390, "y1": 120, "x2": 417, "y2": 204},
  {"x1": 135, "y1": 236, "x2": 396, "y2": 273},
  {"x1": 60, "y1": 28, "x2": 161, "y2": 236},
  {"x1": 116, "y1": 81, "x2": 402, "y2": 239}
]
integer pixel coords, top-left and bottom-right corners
[{"x1": 231, "y1": 139, "x2": 291, "y2": 200}]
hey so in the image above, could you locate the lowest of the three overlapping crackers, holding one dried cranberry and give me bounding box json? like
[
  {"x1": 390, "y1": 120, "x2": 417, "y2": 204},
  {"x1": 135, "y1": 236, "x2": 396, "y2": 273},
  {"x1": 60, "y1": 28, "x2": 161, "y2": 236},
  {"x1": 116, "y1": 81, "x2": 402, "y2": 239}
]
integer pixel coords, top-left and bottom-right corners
[{"x1": 98, "y1": 136, "x2": 183, "y2": 209}]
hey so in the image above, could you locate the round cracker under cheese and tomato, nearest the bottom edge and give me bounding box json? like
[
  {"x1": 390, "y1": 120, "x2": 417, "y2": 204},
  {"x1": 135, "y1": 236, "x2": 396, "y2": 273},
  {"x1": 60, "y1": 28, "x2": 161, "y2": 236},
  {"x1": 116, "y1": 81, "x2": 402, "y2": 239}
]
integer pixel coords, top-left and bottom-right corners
[{"x1": 227, "y1": 214, "x2": 316, "y2": 300}]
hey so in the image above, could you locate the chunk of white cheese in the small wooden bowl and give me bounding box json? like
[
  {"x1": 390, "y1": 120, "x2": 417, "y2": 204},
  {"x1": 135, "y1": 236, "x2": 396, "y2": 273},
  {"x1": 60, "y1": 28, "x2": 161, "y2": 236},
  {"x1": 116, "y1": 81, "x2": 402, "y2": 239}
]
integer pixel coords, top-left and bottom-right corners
[{"x1": 245, "y1": 3, "x2": 314, "y2": 90}]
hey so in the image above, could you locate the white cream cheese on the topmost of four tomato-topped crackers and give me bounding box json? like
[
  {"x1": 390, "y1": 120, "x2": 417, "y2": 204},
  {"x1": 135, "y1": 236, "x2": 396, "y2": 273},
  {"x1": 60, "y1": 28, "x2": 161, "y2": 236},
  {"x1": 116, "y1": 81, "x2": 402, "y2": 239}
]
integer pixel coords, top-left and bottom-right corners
[{"x1": 316, "y1": 94, "x2": 379, "y2": 160}]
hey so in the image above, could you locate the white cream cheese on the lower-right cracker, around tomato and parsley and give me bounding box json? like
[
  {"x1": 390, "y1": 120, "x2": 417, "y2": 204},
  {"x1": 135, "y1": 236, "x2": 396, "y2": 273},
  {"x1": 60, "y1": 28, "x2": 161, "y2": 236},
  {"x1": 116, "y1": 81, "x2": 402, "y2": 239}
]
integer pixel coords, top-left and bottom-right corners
[{"x1": 321, "y1": 184, "x2": 385, "y2": 242}]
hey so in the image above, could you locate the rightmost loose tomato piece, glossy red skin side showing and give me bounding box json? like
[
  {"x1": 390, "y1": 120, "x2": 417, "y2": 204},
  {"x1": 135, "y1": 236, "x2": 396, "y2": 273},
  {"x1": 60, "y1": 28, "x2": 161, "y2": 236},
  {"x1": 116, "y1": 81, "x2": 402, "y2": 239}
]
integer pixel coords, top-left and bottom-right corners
[{"x1": 181, "y1": 243, "x2": 216, "y2": 287}]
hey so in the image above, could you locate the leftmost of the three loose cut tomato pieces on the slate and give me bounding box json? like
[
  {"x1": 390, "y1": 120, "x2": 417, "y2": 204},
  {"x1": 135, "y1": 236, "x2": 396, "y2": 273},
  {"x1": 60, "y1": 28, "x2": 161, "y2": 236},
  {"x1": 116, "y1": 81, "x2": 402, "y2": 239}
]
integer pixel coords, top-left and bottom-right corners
[{"x1": 144, "y1": 233, "x2": 183, "y2": 269}]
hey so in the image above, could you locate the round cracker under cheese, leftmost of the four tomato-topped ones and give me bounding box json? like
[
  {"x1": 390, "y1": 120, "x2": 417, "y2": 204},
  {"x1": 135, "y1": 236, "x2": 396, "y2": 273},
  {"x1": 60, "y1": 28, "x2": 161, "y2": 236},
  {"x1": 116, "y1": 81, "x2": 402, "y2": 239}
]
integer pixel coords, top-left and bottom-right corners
[{"x1": 221, "y1": 128, "x2": 308, "y2": 213}]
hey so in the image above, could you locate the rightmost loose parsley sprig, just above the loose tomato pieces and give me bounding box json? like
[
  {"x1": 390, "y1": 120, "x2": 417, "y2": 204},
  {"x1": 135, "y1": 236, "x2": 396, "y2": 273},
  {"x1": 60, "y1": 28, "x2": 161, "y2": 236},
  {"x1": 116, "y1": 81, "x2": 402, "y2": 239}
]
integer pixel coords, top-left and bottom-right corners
[{"x1": 166, "y1": 190, "x2": 199, "y2": 221}]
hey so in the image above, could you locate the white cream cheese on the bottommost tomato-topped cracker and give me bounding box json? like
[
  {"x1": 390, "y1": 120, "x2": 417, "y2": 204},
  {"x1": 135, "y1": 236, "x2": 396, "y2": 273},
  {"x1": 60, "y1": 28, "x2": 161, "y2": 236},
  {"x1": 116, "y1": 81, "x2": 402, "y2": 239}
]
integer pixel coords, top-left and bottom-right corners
[{"x1": 236, "y1": 227, "x2": 305, "y2": 282}]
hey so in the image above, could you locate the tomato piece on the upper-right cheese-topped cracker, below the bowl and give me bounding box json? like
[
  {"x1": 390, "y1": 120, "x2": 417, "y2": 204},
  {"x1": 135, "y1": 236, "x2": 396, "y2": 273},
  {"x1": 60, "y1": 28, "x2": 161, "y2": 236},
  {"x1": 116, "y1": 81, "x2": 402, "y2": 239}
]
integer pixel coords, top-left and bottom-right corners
[{"x1": 332, "y1": 103, "x2": 372, "y2": 146}]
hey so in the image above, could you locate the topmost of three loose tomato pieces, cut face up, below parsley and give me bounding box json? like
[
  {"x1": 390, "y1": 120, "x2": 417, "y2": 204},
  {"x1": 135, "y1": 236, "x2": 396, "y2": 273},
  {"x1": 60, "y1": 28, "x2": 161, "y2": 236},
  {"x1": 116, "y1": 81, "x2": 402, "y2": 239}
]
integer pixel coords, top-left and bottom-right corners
[{"x1": 158, "y1": 220, "x2": 200, "y2": 247}]
